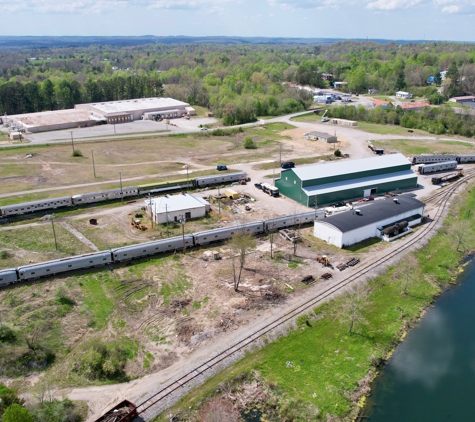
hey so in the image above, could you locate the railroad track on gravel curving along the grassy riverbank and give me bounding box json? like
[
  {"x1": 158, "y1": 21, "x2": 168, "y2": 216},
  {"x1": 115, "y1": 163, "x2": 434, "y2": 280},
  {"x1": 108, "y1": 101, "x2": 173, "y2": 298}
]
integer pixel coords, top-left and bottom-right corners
[{"x1": 137, "y1": 170, "x2": 475, "y2": 420}]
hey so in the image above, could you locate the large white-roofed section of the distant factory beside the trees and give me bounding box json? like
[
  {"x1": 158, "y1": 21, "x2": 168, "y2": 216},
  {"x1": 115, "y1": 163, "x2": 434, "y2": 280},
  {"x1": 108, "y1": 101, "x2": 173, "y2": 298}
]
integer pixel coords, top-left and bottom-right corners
[{"x1": 74, "y1": 97, "x2": 196, "y2": 124}]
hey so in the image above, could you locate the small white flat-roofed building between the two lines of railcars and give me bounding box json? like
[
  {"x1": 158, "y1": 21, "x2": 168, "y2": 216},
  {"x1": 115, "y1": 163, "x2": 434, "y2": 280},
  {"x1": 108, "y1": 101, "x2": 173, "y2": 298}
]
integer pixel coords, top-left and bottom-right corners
[{"x1": 145, "y1": 193, "x2": 211, "y2": 224}]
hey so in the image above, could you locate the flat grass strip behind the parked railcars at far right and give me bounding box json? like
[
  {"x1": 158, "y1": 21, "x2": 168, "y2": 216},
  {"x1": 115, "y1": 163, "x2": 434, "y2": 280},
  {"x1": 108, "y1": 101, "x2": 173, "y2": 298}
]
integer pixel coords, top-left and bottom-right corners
[{"x1": 373, "y1": 139, "x2": 475, "y2": 155}]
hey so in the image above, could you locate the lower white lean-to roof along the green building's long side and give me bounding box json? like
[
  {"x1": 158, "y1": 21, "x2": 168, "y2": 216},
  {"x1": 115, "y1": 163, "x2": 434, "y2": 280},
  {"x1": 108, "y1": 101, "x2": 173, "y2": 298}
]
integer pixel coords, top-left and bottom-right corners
[{"x1": 302, "y1": 170, "x2": 417, "y2": 196}]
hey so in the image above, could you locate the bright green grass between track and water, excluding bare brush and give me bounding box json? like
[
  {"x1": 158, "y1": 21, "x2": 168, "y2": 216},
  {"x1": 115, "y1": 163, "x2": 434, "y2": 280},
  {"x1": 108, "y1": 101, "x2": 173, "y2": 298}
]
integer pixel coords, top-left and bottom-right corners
[{"x1": 157, "y1": 186, "x2": 475, "y2": 421}]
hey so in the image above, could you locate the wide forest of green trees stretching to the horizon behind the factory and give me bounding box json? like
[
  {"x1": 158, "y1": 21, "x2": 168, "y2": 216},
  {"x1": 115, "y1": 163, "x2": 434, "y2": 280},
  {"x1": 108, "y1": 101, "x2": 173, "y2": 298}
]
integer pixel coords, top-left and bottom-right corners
[{"x1": 0, "y1": 41, "x2": 475, "y2": 125}]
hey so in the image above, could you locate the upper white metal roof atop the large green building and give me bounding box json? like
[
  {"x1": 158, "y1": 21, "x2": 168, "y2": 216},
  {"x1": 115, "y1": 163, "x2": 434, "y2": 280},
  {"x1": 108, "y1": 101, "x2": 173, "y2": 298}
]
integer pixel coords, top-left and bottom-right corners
[{"x1": 292, "y1": 154, "x2": 411, "y2": 181}]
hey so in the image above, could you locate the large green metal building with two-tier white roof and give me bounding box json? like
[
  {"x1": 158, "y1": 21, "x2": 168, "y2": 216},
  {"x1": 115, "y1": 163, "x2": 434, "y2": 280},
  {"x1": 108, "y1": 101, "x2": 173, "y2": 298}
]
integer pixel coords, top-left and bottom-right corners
[{"x1": 275, "y1": 154, "x2": 417, "y2": 207}]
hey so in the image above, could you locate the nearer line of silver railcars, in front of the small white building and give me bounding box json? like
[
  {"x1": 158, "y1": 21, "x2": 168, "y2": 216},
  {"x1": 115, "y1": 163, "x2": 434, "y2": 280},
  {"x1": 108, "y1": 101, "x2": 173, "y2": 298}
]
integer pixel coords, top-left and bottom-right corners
[{"x1": 0, "y1": 211, "x2": 317, "y2": 286}]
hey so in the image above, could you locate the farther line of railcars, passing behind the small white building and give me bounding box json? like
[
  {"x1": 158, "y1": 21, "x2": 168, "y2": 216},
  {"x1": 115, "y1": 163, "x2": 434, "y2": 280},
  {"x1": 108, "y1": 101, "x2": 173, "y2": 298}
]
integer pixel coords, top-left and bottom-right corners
[{"x1": 0, "y1": 171, "x2": 247, "y2": 217}]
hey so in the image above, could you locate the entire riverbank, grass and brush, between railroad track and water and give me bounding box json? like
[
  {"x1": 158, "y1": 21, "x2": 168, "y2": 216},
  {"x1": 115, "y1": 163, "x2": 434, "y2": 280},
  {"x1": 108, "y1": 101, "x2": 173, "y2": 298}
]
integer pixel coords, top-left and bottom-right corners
[{"x1": 157, "y1": 185, "x2": 475, "y2": 421}]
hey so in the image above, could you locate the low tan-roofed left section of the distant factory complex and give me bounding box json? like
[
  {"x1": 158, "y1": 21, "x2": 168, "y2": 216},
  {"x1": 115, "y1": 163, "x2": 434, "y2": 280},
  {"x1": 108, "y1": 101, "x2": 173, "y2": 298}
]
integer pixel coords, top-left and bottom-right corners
[{"x1": 3, "y1": 109, "x2": 103, "y2": 133}]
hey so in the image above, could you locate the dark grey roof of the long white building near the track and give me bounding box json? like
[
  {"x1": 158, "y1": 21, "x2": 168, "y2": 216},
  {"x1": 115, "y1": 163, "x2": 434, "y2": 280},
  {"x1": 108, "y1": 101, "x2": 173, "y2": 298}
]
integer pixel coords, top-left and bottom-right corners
[{"x1": 316, "y1": 194, "x2": 425, "y2": 233}]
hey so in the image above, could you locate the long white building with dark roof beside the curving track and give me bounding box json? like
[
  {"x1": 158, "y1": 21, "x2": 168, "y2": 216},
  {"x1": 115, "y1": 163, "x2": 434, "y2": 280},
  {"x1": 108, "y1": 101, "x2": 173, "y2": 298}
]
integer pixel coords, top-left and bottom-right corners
[{"x1": 314, "y1": 194, "x2": 425, "y2": 248}]
